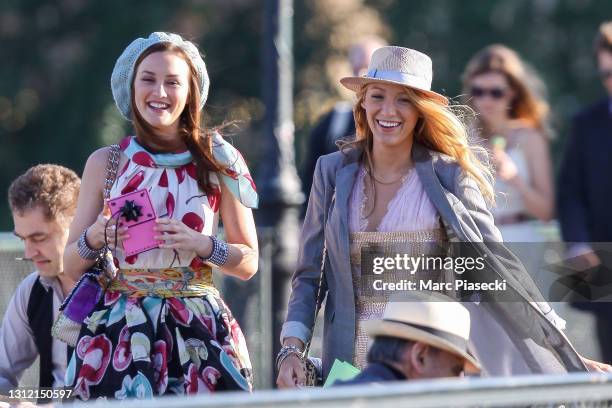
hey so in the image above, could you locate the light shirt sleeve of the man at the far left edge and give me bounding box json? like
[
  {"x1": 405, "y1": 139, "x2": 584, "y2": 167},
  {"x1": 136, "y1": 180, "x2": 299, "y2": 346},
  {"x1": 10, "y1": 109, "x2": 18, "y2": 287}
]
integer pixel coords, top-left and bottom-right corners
[{"x1": 0, "y1": 275, "x2": 38, "y2": 394}]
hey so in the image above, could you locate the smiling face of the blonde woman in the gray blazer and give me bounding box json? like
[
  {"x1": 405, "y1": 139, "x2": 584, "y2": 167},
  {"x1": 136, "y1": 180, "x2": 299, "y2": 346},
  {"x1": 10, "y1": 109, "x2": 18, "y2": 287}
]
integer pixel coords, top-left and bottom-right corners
[{"x1": 361, "y1": 83, "x2": 419, "y2": 148}]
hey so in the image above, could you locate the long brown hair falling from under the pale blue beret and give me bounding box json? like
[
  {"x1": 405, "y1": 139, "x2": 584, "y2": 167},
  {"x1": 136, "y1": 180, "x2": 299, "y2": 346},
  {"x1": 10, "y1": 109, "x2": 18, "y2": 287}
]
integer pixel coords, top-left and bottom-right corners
[{"x1": 131, "y1": 42, "x2": 227, "y2": 194}]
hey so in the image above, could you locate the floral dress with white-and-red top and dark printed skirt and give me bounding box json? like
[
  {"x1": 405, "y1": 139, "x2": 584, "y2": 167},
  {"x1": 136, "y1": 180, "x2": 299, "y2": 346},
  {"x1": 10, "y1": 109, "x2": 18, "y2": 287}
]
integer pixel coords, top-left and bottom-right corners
[{"x1": 66, "y1": 135, "x2": 257, "y2": 400}]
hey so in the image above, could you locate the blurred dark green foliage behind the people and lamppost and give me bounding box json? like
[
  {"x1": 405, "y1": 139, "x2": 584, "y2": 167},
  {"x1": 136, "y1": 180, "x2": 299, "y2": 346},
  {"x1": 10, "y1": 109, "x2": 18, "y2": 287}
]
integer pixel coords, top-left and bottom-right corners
[{"x1": 0, "y1": 0, "x2": 612, "y2": 230}]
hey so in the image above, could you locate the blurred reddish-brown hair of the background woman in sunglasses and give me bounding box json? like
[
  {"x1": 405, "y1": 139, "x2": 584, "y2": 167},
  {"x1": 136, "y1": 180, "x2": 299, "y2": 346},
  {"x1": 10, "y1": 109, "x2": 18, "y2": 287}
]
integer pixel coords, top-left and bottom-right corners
[{"x1": 462, "y1": 44, "x2": 552, "y2": 138}]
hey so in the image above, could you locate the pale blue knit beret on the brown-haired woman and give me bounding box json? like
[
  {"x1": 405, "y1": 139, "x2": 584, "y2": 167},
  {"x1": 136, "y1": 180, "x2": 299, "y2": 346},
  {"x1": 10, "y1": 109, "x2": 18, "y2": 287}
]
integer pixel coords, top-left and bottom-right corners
[{"x1": 111, "y1": 32, "x2": 210, "y2": 120}]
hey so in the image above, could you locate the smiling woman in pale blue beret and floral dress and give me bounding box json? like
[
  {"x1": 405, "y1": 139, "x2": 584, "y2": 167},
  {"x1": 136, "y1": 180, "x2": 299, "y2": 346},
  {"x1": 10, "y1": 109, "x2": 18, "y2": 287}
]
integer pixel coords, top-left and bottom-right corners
[{"x1": 59, "y1": 32, "x2": 258, "y2": 400}]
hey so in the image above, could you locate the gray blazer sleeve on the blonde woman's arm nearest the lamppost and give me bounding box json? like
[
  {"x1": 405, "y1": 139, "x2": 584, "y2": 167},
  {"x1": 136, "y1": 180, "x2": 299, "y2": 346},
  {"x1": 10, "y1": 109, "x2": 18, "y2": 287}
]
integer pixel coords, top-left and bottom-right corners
[{"x1": 281, "y1": 158, "x2": 328, "y2": 343}]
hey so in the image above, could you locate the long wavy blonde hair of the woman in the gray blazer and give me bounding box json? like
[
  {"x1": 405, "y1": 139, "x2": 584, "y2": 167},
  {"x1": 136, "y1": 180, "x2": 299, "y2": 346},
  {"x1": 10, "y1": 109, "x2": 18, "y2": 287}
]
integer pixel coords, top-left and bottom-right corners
[{"x1": 339, "y1": 85, "x2": 495, "y2": 204}]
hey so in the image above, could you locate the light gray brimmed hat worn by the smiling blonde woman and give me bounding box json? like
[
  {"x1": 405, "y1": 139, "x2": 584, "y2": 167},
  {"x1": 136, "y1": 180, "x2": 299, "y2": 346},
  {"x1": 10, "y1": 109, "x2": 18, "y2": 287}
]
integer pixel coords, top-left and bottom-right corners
[{"x1": 340, "y1": 46, "x2": 448, "y2": 105}]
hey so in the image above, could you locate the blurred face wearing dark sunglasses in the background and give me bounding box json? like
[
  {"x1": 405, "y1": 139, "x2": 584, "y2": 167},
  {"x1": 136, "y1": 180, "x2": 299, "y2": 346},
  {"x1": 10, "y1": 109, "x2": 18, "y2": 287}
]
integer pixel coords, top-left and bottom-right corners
[{"x1": 469, "y1": 72, "x2": 514, "y2": 124}]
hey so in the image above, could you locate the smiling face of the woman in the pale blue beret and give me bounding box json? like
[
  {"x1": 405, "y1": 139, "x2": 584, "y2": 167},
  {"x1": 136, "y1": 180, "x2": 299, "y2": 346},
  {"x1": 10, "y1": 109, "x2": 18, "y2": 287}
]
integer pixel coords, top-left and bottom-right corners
[{"x1": 134, "y1": 51, "x2": 190, "y2": 136}]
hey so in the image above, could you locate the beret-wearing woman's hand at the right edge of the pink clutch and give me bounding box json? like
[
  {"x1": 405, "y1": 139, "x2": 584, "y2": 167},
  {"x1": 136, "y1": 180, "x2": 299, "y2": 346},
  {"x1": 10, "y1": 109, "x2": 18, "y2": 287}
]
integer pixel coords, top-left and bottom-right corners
[{"x1": 154, "y1": 218, "x2": 212, "y2": 256}]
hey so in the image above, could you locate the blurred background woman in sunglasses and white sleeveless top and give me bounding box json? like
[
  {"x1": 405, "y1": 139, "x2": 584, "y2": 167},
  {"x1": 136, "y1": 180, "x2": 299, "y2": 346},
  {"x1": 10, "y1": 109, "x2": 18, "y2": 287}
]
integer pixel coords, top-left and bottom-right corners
[{"x1": 463, "y1": 45, "x2": 554, "y2": 242}]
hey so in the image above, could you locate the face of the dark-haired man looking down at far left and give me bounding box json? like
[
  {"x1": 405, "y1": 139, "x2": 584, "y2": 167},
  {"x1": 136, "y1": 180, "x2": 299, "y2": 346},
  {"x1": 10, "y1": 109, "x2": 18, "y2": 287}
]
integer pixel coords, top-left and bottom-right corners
[{"x1": 13, "y1": 207, "x2": 69, "y2": 278}]
